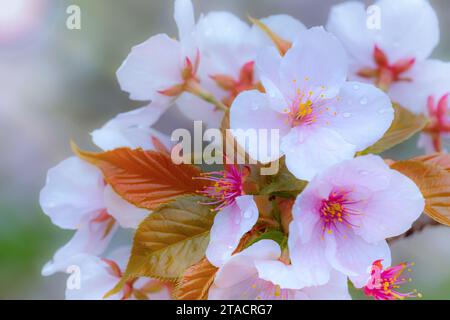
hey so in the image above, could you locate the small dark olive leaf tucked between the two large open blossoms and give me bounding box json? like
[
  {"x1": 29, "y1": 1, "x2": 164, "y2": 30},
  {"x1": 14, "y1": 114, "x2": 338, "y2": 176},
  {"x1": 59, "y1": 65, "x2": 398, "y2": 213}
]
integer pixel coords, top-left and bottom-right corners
[{"x1": 259, "y1": 163, "x2": 308, "y2": 198}]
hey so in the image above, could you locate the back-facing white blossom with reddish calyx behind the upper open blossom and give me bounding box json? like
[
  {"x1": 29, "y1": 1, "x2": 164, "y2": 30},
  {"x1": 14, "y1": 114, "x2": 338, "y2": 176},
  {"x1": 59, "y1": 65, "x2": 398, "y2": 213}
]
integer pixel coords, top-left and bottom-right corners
[{"x1": 177, "y1": 12, "x2": 306, "y2": 127}]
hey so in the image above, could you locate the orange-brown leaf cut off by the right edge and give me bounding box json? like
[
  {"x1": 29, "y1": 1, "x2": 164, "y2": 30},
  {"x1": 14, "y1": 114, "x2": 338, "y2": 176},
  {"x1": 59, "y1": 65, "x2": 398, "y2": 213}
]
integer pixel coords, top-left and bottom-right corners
[{"x1": 391, "y1": 160, "x2": 450, "y2": 226}]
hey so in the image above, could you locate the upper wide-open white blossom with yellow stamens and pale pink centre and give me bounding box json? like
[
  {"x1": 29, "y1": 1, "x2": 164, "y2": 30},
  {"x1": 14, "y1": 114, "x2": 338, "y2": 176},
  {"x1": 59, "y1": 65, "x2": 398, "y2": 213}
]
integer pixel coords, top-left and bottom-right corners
[{"x1": 230, "y1": 28, "x2": 393, "y2": 180}]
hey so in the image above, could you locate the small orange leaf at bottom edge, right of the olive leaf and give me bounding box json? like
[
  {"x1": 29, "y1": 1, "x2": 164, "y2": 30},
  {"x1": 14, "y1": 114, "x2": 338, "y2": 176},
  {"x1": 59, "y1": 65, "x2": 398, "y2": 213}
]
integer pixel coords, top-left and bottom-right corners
[{"x1": 174, "y1": 258, "x2": 218, "y2": 300}]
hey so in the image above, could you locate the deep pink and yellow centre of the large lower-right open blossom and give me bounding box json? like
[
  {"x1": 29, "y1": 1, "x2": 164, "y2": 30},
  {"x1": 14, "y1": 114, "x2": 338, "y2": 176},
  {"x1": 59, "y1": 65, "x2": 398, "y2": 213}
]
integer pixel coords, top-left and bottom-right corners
[{"x1": 319, "y1": 192, "x2": 360, "y2": 238}]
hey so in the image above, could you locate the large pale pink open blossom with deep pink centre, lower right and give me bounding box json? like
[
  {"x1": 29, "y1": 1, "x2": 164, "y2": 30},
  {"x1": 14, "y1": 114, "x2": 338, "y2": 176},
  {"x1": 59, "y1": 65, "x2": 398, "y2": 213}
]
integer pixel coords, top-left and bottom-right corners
[{"x1": 288, "y1": 155, "x2": 424, "y2": 285}]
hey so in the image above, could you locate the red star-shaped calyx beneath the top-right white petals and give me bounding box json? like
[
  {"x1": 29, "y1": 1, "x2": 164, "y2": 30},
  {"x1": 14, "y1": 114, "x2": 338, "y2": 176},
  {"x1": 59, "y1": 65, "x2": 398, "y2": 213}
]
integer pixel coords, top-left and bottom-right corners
[{"x1": 358, "y1": 46, "x2": 416, "y2": 91}]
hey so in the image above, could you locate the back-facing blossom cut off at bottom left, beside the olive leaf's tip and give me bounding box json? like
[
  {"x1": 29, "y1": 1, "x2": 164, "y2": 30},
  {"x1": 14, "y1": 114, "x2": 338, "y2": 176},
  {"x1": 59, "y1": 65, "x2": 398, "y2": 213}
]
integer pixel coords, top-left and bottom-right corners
[{"x1": 66, "y1": 247, "x2": 170, "y2": 300}]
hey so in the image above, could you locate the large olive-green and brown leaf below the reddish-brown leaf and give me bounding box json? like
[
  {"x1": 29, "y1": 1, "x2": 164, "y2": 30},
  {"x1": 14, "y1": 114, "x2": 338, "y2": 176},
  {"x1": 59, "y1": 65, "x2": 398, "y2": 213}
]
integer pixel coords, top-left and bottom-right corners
[{"x1": 107, "y1": 196, "x2": 215, "y2": 296}]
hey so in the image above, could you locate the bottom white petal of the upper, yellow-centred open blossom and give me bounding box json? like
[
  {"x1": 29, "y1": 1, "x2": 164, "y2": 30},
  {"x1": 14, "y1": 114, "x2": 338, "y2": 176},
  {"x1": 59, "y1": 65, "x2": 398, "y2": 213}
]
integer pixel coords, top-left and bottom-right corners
[{"x1": 281, "y1": 126, "x2": 356, "y2": 181}]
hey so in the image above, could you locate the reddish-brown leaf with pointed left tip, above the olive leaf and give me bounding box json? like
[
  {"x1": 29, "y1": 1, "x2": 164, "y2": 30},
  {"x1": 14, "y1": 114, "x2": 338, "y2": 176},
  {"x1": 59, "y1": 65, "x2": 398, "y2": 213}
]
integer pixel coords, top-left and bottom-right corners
[{"x1": 73, "y1": 145, "x2": 206, "y2": 210}]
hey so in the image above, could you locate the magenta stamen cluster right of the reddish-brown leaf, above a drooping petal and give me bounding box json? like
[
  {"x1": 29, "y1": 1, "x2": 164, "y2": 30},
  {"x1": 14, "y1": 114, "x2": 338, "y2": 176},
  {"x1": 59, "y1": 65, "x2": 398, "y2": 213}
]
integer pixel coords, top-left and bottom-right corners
[{"x1": 198, "y1": 165, "x2": 250, "y2": 210}]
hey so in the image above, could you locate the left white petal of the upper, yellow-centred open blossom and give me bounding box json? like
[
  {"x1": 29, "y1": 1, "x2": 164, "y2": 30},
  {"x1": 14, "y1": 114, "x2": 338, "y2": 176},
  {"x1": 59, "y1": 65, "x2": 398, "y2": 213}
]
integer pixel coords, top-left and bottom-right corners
[{"x1": 230, "y1": 90, "x2": 289, "y2": 163}]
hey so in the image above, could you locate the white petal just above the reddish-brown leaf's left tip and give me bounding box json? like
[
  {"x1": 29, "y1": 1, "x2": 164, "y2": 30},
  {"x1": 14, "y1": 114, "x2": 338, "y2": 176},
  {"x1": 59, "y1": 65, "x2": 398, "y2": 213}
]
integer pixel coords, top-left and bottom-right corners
[{"x1": 92, "y1": 103, "x2": 170, "y2": 151}]
